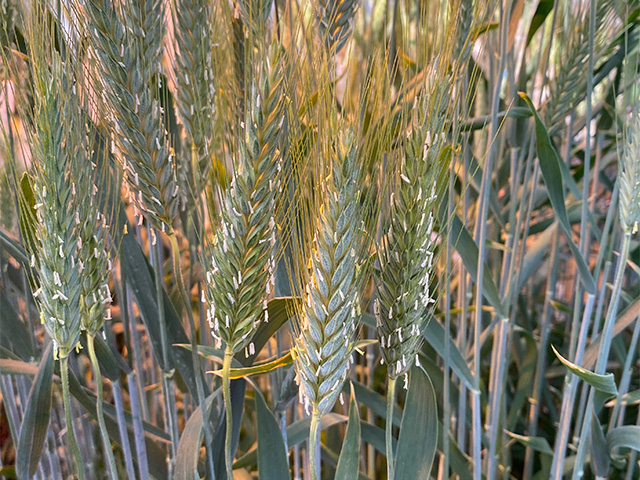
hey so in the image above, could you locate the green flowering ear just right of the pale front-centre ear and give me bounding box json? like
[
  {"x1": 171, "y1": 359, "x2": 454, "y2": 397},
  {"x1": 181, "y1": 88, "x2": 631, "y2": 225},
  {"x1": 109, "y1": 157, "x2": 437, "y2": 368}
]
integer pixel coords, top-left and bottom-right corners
[{"x1": 374, "y1": 82, "x2": 450, "y2": 378}]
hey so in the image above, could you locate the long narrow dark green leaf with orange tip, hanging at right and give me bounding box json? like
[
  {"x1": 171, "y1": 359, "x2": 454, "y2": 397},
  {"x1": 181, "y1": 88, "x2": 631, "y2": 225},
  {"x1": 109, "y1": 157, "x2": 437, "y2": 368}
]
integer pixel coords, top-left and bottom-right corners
[{"x1": 519, "y1": 92, "x2": 596, "y2": 293}]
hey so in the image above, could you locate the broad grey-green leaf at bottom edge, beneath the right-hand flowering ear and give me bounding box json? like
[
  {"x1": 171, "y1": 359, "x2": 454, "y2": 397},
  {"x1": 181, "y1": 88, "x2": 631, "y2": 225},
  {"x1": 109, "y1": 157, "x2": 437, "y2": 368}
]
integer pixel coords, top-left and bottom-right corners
[{"x1": 395, "y1": 366, "x2": 438, "y2": 480}]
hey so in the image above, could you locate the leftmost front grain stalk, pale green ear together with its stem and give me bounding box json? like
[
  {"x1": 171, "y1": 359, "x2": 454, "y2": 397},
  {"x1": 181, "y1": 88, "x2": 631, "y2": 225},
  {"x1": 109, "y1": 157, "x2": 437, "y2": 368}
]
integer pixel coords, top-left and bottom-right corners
[{"x1": 21, "y1": 11, "x2": 90, "y2": 479}]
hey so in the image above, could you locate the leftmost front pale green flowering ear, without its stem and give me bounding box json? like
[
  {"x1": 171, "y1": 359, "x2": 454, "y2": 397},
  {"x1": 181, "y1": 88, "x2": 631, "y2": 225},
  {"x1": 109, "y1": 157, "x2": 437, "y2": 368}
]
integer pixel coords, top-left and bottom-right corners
[{"x1": 31, "y1": 47, "x2": 82, "y2": 358}]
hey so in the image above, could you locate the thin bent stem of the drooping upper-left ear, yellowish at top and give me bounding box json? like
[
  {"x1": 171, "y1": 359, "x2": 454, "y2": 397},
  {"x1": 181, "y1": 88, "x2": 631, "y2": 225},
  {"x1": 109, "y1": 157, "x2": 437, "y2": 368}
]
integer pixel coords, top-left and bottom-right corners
[{"x1": 169, "y1": 231, "x2": 214, "y2": 472}]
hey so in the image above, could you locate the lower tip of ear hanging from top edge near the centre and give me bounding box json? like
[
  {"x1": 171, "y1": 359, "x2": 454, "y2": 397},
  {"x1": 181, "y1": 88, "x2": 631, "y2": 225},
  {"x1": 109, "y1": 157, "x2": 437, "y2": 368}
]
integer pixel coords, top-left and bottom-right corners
[{"x1": 317, "y1": 0, "x2": 358, "y2": 53}]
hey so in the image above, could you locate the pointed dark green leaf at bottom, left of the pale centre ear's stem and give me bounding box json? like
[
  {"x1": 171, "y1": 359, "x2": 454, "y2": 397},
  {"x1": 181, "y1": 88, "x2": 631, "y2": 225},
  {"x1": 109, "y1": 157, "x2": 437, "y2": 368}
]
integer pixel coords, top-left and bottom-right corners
[{"x1": 256, "y1": 390, "x2": 291, "y2": 480}]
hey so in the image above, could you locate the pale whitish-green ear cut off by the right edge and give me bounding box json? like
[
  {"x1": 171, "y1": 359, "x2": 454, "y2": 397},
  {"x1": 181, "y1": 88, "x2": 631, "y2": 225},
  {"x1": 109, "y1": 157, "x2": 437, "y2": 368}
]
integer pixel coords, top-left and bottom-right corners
[{"x1": 618, "y1": 107, "x2": 640, "y2": 235}]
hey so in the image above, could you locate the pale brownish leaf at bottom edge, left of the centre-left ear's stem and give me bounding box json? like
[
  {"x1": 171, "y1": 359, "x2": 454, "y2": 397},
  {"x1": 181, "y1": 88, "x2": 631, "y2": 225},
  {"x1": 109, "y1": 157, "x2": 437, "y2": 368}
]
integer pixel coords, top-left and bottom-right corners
[{"x1": 173, "y1": 387, "x2": 222, "y2": 480}]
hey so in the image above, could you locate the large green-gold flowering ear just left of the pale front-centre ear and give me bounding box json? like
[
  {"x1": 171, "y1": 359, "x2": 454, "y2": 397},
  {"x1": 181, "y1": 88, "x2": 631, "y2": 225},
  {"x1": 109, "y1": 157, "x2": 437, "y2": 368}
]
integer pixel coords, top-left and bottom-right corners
[{"x1": 203, "y1": 48, "x2": 285, "y2": 353}]
